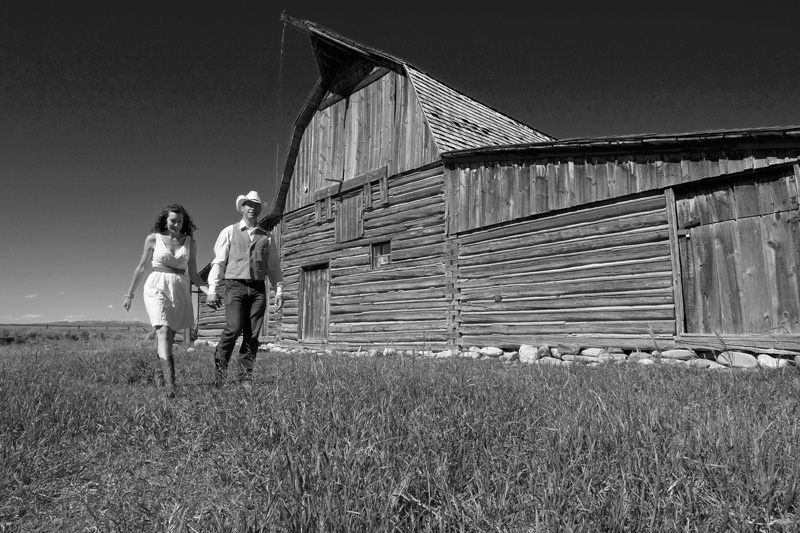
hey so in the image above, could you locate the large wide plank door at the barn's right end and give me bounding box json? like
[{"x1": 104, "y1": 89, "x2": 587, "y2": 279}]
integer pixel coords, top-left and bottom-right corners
[{"x1": 676, "y1": 168, "x2": 800, "y2": 335}]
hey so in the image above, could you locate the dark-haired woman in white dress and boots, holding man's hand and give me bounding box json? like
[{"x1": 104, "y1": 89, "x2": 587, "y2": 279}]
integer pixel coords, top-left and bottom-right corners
[{"x1": 122, "y1": 204, "x2": 208, "y2": 398}]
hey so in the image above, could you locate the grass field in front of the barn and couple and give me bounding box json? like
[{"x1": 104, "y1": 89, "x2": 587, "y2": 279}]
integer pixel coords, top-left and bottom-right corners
[{"x1": 0, "y1": 337, "x2": 800, "y2": 532}]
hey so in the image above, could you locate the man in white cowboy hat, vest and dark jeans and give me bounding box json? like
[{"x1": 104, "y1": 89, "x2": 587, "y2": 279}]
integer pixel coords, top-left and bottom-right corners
[{"x1": 206, "y1": 191, "x2": 283, "y2": 387}]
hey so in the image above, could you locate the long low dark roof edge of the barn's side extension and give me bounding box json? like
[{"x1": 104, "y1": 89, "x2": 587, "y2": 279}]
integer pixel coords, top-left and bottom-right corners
[{"x1": 442, "y1": 126, "x2": 800, "y2": 163}]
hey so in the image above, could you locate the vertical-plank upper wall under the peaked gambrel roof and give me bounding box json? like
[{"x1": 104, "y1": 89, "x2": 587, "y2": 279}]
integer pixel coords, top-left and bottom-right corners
[{"x1": 284, "y1": 72, "x2": 439, "y2": 213}]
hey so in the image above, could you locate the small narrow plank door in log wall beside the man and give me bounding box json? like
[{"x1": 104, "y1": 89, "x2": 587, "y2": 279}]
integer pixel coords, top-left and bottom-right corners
[{"x1": 297, "y1": 264, "x2": 330, "y2": 342}]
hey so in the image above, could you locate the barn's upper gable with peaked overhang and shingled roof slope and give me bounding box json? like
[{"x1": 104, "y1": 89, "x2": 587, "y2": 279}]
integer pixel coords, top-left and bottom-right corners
[{"x1": 264, "y1": 14, "x2": 553, "y2": 220}]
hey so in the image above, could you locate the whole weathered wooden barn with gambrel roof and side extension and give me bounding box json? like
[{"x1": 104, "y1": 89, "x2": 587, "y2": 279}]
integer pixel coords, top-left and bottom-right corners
[{"x1": 199, "y1": 16, "x2": 800, "y2": 353}]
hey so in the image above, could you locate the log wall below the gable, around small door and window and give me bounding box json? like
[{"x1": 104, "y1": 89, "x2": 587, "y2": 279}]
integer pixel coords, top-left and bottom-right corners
[{"x1": 280, "y1": 166, "x2": 450, "y2": 348}]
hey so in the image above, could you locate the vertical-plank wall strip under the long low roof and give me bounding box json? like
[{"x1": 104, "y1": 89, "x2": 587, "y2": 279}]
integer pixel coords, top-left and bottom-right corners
[{"x1": 446, "y1": 149, "x2": 800, "y2": 235}]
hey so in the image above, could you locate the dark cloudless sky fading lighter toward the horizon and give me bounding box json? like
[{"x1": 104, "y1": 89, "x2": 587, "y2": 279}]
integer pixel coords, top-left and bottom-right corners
[{"x1": 0, "y1": 1, "x2": 800, "y2": 323}]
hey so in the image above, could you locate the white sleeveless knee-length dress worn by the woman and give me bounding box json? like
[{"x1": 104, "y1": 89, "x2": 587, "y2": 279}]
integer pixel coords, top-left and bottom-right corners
[{"x1": 143, "y1": 233, "x2": 194, "y2": 331}]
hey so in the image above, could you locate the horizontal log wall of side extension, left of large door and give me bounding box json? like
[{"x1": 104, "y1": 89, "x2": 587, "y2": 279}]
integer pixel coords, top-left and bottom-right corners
[{"x1": 454, "y1": 194, "x2": 675, "y2": 349}]
